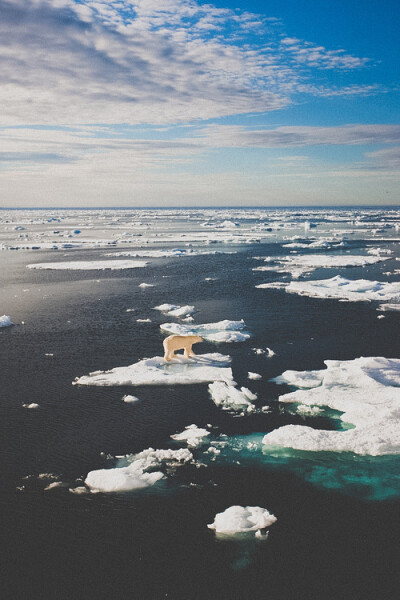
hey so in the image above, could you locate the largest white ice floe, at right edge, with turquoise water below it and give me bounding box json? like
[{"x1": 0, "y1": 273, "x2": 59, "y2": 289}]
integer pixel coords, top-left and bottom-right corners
[{"x1": 263, "y1": 357, "x2": 400, "y2": 456}]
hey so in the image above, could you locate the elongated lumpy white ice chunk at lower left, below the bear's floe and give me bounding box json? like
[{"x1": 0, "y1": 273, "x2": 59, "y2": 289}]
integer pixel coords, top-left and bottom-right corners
[{"x1": 85, "y1": 448, "x2": 193, "y2": 493}]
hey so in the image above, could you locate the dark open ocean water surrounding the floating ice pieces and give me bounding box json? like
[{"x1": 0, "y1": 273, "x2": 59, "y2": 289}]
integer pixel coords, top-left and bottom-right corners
[{"x1": 0, "y1": 213, "x2": 400, "y2": 600}]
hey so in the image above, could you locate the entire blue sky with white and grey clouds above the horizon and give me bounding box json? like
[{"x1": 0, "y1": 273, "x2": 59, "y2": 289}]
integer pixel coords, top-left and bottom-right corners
[{"x1": 0, "y1": 0, "x2": 400, "y2": 208}]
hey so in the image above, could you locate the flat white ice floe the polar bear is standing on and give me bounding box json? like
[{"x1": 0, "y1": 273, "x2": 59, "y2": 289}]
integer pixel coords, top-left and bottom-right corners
[{"x1": 74, "y1": 353, "x2": 233, "y2": 386}]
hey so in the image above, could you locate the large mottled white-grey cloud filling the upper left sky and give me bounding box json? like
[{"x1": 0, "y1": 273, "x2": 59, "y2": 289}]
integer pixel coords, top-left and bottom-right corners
[{"x1": 0, "y1": 0, "x2": 376, "y2": 125}]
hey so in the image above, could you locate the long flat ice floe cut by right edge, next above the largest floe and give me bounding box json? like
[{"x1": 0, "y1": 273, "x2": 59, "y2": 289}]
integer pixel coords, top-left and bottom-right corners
[{"x1": 256, "y1": 275, "x2": 400, "y2": 303}]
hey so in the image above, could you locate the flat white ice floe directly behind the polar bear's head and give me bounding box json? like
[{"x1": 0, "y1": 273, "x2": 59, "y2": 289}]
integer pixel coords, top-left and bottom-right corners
[{"x1": 160, "y1": 320, "x2": 250, "y2": 342}]
